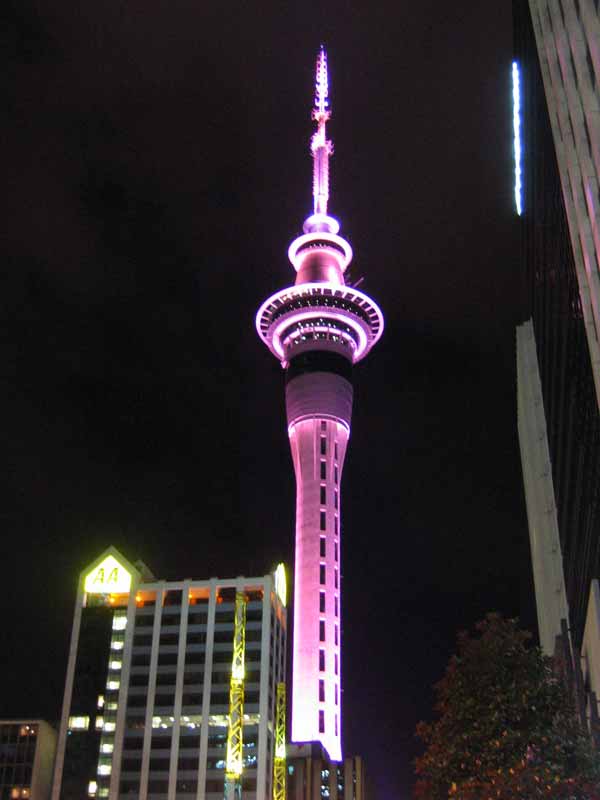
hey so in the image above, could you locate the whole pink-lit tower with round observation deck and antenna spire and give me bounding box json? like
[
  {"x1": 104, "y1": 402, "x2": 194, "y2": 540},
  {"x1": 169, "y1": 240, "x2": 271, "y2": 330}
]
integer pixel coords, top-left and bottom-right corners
[{"x1": 256, "y1": 48, "x2": 383, "y2": 761}]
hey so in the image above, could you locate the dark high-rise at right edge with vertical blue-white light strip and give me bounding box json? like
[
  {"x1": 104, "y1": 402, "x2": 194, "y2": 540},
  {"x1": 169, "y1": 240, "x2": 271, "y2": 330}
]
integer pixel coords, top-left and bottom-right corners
[{"x1": 513, "y1": 0, "x2": 600, "y2": 680}]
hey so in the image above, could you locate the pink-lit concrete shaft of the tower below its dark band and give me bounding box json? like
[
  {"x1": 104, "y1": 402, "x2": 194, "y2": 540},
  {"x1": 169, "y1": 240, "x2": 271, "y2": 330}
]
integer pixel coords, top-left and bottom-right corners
[{"x1": 286, "y1": 371, "x2": 352, "y2": 761}]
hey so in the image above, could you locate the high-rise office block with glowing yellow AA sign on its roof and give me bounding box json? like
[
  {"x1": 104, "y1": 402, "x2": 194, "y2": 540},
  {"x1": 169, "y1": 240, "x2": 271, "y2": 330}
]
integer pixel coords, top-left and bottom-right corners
[{"x1": 52, "y1": 548, "x2": 286, "y2": 800}]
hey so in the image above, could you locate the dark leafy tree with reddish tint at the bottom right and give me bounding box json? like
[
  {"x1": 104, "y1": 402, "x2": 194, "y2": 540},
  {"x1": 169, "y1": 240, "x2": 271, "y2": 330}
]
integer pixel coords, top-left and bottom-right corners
[{"x1": 415, "y1": 614, "x2": 600, "y2": 800}]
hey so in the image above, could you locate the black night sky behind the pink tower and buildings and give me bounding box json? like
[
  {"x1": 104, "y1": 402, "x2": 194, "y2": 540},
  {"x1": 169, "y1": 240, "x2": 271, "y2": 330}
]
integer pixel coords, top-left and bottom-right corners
[{"x1": 0, "y1": 0, "x2": 535, "y2": 800}]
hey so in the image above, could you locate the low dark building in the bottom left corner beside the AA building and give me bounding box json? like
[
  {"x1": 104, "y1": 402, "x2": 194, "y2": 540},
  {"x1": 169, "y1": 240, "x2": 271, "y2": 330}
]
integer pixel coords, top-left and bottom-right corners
[{"x1": 0, "y1": 719, "x2": 56, "y2": 800}]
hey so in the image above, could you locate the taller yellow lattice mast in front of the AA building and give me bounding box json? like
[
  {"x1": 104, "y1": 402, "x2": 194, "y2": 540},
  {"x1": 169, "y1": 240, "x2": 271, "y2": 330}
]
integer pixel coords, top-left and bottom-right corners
[{"x1": 224, "y1": 592, "x2": 247, "y2": 800}]
